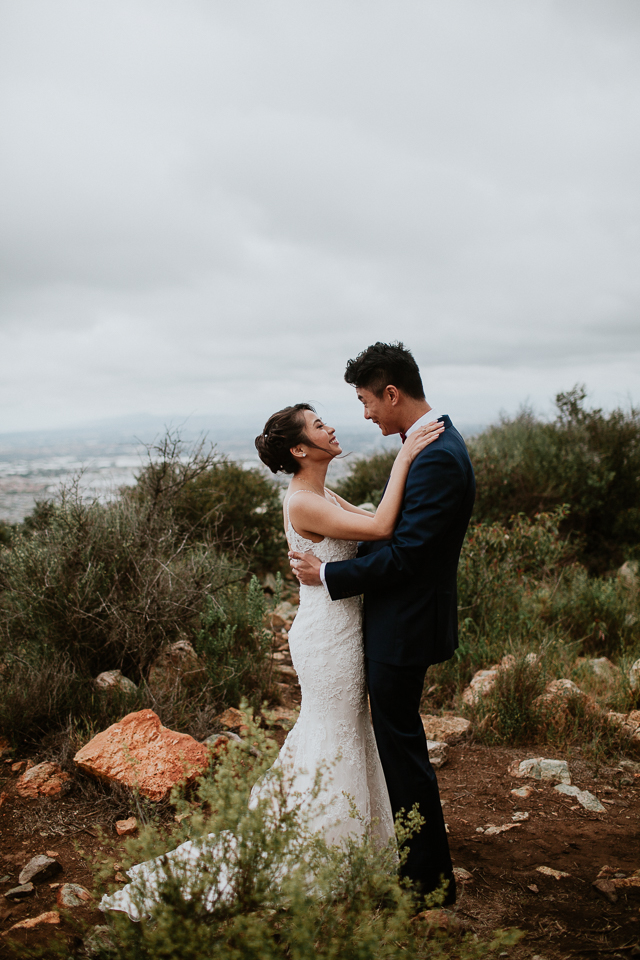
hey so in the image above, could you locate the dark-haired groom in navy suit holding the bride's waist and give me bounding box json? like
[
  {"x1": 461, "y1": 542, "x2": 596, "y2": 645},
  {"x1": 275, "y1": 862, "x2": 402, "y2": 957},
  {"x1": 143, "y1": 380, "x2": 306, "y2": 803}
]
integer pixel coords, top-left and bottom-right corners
[{"x1": 290, "y1": 343, "x2": 475, "y2": 905}]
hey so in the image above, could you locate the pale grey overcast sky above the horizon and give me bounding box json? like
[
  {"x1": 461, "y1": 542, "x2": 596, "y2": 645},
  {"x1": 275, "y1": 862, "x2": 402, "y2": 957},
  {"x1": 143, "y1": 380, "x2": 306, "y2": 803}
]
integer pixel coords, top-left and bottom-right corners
[{"x1": 0, "y1": 0, "x2": 640, "y2": 432}]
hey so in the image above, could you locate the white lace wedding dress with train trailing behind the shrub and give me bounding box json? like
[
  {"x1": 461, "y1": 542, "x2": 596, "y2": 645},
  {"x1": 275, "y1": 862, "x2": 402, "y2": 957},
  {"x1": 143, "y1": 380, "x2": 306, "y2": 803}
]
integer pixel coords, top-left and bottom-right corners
[{"x1": 100, "y1": 490, "x2": 394, "y2": 920}]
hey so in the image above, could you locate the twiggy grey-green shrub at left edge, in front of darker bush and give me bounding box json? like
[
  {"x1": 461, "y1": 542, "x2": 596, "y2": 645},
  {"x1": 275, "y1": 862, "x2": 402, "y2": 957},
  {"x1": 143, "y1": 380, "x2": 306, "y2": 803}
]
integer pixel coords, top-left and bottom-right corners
[{"x1": 0, "y1": 492, "x2": 242, "y2": 682}]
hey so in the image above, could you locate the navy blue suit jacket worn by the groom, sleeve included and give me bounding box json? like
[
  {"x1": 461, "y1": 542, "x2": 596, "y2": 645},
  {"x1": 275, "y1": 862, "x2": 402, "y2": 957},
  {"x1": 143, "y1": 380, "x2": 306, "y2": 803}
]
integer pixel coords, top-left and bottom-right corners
[{"x1": 325, "y1": 417, "x2": 476, "y2": 666}]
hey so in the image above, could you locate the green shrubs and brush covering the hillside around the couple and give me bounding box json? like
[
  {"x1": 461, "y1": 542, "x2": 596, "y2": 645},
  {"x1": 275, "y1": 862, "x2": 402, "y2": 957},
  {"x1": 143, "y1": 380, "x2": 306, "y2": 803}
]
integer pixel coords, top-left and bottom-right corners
[{"x1": 0, "y1": 389, "x2": 640, "y2": 960}]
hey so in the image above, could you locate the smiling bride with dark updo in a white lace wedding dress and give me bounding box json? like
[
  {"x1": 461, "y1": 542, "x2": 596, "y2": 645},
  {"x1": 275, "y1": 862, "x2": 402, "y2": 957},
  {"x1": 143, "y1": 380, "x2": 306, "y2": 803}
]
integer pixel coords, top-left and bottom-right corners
[{"x1": 100, "y1": 403, "x2": 444, "y2": 920}]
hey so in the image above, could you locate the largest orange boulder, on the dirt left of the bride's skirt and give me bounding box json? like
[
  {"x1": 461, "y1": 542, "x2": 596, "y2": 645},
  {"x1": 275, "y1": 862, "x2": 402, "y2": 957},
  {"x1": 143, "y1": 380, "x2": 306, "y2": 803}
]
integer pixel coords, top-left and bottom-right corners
[{"x1": 74, "y1": 710, "x2": 209, "y2": 800}]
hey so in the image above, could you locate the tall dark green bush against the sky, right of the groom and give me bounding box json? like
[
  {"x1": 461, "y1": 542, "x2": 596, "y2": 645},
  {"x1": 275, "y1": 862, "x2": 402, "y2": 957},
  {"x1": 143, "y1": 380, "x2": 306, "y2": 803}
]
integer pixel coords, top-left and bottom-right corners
[{"x1": 469, "y1": 387, "x2": 640, "y2": 573}]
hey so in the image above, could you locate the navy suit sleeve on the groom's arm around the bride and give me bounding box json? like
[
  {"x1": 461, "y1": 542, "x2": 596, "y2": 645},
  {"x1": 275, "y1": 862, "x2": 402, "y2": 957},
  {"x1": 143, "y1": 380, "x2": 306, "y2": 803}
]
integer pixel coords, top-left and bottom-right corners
[{"x1": 325, "y1": 447, "x2": 466, "y2": 600}]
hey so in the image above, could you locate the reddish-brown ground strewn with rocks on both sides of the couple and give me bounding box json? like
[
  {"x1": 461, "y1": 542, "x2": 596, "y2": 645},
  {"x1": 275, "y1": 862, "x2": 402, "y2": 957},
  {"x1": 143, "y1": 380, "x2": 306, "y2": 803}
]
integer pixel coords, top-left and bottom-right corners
[{"x1": 0, "y1": 605, "x2": 640, "y2": 960}]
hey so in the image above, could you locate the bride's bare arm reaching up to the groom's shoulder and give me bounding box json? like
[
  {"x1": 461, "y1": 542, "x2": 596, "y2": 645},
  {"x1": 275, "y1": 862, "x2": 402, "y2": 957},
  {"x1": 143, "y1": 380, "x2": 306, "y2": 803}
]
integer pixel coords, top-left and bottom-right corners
[{"x1": 290, "y1": 422, "x2": 444, "y2": 540}]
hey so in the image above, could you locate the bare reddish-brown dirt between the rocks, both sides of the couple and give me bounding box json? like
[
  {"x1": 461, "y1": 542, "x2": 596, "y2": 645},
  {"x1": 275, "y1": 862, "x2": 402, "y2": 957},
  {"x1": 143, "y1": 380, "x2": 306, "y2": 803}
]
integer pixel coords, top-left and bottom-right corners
[{"x1": 0, "y1": 733, "x2": 640, "y2": 960}]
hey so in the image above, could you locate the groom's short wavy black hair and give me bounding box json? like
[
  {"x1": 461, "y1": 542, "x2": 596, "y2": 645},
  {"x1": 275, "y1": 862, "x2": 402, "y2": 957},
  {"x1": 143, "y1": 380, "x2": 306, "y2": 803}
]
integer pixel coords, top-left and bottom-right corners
[{"x1": 344, "y1": 341, "x2": 424, "y2": 400}]
